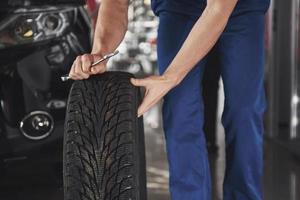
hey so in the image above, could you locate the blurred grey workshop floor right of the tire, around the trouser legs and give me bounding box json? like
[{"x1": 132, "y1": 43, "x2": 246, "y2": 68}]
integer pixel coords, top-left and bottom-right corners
[{"x1": 145, "y1": 102, "x2": 300, "y2": 200}]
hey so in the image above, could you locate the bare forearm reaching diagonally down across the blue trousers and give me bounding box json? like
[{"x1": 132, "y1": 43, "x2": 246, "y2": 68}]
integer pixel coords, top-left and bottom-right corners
[{"x1": 164, "y1": 0, "x2": 237, "y2": 84}]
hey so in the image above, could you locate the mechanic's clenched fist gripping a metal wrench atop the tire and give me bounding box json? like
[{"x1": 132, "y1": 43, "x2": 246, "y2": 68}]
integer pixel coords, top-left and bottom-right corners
[{"x1": 69, "y1": 54, "x2": 107, "y2": 80}]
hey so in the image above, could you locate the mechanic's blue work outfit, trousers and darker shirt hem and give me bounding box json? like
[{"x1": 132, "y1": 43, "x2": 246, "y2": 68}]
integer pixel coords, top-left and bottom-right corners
[{"x1": 152, "y1": 0, "x2": 269, "y2": 200}]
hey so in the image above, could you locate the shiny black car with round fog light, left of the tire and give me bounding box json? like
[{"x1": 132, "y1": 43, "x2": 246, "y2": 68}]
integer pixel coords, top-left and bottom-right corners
[{"x1": 0, "y1": 0, "x2": 97, "y2": 167}]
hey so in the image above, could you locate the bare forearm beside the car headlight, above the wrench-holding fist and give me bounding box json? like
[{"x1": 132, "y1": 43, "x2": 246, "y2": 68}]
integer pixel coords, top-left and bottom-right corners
[{"x1": 92, "y1": 0, "x2": 129, "y2": 54}]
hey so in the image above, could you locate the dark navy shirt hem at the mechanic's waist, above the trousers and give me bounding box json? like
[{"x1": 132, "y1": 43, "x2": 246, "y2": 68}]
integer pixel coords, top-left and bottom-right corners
[{"x1": 151, "y1": 0, "x2": 270, "y2": 17}]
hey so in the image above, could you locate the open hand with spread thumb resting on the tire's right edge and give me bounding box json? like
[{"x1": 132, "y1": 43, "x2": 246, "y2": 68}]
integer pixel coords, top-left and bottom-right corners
[{"x1": 130, "y1": 75, "x2": 177, "y2": 117}]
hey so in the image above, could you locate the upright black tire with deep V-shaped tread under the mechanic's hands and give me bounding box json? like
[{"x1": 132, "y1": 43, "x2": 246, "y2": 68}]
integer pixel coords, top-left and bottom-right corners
[{"x1": 63, "y1": 72, "x2": 147, "y2": 200}]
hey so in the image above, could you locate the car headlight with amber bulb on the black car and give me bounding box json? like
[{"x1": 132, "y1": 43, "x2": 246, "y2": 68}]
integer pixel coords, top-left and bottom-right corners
[{"x1": 0, "y1": 7, "x2": 76, "y2": 49}]
